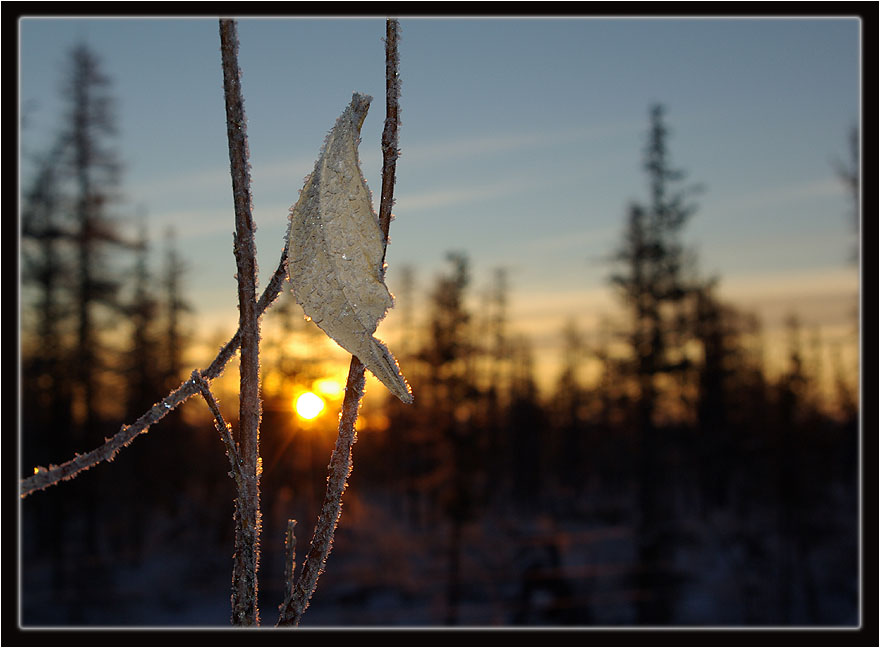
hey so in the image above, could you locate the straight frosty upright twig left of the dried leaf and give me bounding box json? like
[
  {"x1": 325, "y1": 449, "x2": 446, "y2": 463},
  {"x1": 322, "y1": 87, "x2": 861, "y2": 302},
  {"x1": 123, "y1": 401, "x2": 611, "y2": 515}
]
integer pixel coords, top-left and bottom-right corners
[{"x1": 220, "y1": 19, "x2": 261, "y2": 626}]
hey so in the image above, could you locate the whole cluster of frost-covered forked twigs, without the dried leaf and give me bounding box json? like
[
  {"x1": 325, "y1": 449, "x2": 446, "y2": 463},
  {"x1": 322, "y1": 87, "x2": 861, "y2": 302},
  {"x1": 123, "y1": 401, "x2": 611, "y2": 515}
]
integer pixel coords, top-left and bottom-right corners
[{"x1": 19, "y1": 19, "x2": 400, "y2": 626}]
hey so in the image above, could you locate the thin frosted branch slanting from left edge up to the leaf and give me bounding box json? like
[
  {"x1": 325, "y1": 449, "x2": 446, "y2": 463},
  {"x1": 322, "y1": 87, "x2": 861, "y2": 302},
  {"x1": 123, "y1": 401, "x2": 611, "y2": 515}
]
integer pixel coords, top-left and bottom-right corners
[{"x1": 19, "y1": 244, "x2": 288, "y2": 498}]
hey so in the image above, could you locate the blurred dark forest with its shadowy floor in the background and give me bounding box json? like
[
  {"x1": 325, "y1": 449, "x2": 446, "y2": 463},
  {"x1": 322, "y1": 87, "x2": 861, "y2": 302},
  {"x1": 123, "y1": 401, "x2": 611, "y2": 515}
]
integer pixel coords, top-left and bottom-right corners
[{"x1": 19, "y1": 40, "x2": 860, "y2": 627}]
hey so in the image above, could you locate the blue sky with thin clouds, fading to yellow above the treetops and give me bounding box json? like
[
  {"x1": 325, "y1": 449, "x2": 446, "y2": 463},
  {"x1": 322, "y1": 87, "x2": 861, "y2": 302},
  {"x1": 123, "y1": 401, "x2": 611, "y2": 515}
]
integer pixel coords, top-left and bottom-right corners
[{"x1": 20, "y1": 16, "x2": 860, "y2": 390}]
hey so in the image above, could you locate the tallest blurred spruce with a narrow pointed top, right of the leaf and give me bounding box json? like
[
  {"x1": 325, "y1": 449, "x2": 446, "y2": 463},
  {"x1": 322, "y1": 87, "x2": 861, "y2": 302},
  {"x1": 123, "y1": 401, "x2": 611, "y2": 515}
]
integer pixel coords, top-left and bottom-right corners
[{"x1": 611, "y1": 105, "x2": 695, "y2": 624}]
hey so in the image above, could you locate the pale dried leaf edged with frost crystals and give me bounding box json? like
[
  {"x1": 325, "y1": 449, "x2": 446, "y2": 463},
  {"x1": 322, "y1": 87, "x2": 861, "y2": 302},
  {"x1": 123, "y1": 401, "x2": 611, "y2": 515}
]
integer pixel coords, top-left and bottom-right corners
[{"x1": 288, "y1": 94, "x2": 412, "y2": 403}]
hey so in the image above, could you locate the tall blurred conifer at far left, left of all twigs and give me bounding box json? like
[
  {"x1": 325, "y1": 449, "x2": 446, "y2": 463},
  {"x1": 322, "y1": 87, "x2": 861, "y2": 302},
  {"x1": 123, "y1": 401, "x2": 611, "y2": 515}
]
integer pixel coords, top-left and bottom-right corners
[{"x1": 22, "y1": 45, "x2": 130, "y2": 623}]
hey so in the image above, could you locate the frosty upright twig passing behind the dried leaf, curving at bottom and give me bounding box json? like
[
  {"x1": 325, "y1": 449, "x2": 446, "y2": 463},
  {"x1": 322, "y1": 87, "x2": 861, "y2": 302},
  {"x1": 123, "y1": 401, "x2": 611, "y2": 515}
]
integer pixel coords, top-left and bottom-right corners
[{"x1": 277, "y1": 19, "x2": 400, "y2": 626}]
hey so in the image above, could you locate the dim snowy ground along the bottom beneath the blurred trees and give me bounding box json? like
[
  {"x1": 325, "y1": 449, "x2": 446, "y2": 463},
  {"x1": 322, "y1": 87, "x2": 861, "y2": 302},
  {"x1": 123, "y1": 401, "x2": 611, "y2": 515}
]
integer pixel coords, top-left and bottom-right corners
[{"x1": 15, "y1": 476, "x2": 858, "y2": 628}]
